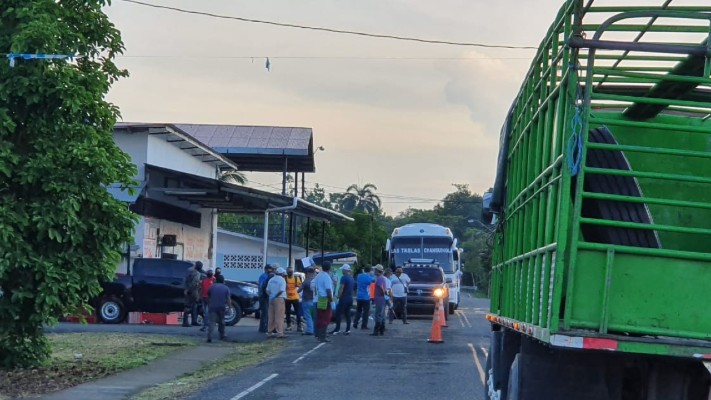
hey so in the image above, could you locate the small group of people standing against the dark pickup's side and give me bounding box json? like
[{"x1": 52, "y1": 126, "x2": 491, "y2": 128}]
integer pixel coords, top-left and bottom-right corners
[{"x1": 183, "y1": 261, "x2": 230, "y2": 343}]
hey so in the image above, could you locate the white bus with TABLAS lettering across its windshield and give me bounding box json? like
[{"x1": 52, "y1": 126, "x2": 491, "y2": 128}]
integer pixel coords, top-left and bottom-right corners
[{"x1": 385, "y1": 223, "x2": 462, "y2": 314}]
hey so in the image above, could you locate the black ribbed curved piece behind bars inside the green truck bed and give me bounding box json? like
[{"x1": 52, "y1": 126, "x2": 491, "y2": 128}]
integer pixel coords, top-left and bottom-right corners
[{"x1": 581, "y1": 126, "x2": 661, "y2": 248}]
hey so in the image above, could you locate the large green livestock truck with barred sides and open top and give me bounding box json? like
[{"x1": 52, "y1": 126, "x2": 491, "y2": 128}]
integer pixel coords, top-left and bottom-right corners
[{"x1": 484, "y1": 0, "x2": 711, "y2": 400}]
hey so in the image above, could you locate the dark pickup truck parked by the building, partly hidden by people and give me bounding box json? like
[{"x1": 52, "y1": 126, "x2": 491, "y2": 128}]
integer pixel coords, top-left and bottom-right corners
[{"x1": 96, "y1": 258, "x2": 259, "y2": 325}]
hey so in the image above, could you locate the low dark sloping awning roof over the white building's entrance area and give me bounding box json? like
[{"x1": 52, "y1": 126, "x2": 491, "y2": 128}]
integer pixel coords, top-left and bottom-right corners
[{"x1": 146, "y1": 164, "x2": 353, "y2": 222}]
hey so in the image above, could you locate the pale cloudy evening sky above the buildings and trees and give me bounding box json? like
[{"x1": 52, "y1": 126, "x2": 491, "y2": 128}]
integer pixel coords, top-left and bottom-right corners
[{"x1": 106, "y1": 0, "x2": 563, "y2": 216}]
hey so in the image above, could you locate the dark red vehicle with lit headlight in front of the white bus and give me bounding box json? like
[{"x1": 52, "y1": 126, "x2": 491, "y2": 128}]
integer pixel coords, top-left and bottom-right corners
[{"x1": 402, "y1": 259, "x2": 449, "y2": 319}]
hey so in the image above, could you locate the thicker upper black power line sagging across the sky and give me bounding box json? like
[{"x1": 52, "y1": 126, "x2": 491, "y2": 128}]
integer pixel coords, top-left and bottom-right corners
[{"x1": 121, "y1": 0, "x2": 538, "y2": 50}]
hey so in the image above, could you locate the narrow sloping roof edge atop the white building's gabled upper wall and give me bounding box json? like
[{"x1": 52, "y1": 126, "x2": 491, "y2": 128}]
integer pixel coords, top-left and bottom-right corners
[{"x1": 114, "y1": 122, "x2": 238, "y2": 171}]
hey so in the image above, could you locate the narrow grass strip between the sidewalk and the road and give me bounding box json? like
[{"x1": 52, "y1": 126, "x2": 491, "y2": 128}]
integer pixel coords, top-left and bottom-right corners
[{"x1": 131, "y1": 340, "x2": 286, "y2": 400}]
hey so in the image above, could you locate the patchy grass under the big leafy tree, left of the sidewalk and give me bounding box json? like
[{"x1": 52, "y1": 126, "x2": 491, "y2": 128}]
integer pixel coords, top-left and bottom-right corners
[{"x1": 0, "y1": 333, "x2": 195, "y2": 398}]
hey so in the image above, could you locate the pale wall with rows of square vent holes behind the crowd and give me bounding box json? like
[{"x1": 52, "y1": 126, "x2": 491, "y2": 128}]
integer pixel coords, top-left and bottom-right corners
[{"x1": 216, "y1": 229, "x2": 306, "y2": 281}]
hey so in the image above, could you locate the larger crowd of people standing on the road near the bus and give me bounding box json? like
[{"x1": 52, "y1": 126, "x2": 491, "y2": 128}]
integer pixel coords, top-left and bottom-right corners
[{"x1": 259, "y1": 261, "x2": 410, "y2": 342}]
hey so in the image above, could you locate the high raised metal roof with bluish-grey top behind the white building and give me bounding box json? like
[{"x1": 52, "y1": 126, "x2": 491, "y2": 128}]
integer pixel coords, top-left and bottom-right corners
[{"x1": 173, "y1": 124, "x2": 316, "y2": 172}]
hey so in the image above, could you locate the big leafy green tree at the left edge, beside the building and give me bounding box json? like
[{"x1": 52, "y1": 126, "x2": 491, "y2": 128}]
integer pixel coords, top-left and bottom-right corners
[{"x1": 0, "y1": 0, "x2": 136, "y2": 368}]
